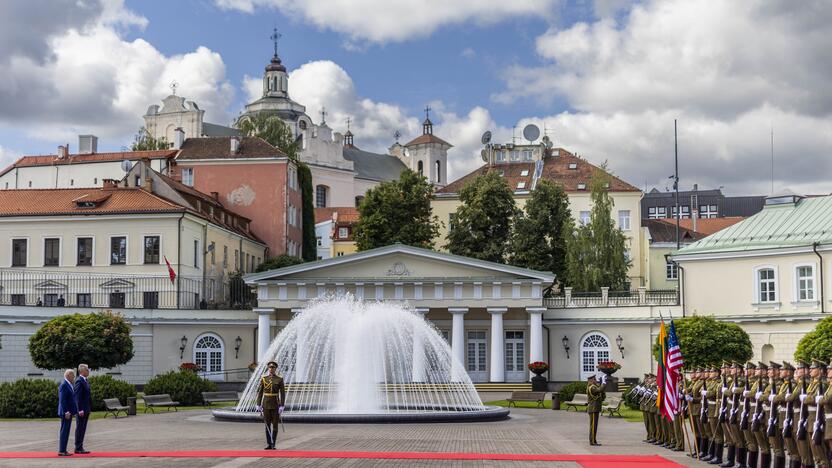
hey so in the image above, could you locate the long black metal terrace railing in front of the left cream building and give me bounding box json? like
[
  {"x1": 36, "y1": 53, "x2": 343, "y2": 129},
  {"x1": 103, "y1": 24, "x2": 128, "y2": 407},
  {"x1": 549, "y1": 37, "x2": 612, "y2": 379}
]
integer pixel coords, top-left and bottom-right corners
[{"x1": 0, "y1": 268, "x2": 257, "y2": 309}]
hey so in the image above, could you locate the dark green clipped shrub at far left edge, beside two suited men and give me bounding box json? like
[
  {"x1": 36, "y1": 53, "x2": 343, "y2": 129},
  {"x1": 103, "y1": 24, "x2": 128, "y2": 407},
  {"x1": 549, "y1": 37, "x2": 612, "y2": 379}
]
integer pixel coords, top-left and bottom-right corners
[{"x1": 0, "y1": 379, "x2": 58, "y2": 418}]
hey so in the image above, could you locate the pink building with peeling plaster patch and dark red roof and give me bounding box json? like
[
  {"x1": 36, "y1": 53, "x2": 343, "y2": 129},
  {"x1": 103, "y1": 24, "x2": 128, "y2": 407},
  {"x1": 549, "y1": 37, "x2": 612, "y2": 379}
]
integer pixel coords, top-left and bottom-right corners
[{"x1": 171, "y1": 136, "x2": 302, "y2": 257}]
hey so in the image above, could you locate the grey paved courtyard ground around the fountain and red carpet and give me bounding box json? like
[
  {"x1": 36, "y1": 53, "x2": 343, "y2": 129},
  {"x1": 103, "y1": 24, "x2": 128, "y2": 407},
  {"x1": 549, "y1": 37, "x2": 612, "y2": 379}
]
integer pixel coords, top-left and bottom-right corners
[{"x1": 0, "y1": 408, "x2": 701, "y2": 468}]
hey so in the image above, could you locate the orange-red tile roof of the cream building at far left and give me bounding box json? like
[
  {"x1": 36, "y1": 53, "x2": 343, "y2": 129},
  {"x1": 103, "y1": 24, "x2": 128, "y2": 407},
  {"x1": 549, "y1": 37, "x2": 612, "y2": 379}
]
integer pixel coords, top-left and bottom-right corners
[{"x1": 0, "y1": 188, "x2": 185, "y2": 217}]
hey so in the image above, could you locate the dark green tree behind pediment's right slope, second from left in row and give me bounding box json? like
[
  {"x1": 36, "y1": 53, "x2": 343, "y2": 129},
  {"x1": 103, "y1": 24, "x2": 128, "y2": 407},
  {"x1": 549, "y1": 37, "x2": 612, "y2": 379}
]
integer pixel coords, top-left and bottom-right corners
[{"x1": 446, "y1": 172, "x2": 518, "y2": 262}]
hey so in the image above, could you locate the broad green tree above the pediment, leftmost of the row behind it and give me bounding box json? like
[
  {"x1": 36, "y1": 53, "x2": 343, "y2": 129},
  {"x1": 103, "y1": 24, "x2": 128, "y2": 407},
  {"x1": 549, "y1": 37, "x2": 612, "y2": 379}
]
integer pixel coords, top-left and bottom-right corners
[{"x1": 354, "y1": 169, "x2": 439, "y2": 250}]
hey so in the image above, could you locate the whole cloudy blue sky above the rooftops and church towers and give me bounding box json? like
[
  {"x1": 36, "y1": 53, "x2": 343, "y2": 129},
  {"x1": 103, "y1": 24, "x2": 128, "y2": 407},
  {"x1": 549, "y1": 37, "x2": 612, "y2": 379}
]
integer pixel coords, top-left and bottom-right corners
[{"x1": 0, "y1": 0, "x2": 832, "y2": 195}]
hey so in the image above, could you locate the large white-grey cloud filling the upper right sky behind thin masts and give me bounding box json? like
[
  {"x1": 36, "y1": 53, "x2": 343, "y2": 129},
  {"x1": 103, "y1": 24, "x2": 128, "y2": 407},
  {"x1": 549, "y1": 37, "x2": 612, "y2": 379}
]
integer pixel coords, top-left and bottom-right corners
[{"x1": 493, "y1": 0, "x2": 832, "y2": 194}]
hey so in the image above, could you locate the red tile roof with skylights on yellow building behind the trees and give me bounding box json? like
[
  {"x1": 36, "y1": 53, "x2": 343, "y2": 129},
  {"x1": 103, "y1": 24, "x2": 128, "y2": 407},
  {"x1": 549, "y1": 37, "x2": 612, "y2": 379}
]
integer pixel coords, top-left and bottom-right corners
[{"x1": 436, "y1": 149, "x2": 641, "y2": 194}]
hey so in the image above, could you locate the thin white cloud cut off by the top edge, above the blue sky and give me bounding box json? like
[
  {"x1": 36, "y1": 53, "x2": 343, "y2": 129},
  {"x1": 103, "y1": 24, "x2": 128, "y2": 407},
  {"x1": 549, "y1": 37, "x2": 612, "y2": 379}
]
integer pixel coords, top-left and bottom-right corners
[{"x1": 215, "y1": 0, "x2": 558, "y2": 43}]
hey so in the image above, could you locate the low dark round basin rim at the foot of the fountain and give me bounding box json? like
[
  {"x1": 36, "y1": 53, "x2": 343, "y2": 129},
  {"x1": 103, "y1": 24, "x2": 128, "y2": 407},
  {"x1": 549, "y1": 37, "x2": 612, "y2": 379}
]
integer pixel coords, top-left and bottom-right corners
[{"x1": 212, "y1": 406, "x2": 509, "y2": 424}]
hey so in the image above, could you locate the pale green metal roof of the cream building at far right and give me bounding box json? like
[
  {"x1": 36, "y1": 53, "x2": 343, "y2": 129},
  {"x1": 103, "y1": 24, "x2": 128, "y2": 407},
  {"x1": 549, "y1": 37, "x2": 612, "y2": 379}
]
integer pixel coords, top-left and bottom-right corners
[{"x1": 674, "y1": 196, "x2": 832, "y2": 257}]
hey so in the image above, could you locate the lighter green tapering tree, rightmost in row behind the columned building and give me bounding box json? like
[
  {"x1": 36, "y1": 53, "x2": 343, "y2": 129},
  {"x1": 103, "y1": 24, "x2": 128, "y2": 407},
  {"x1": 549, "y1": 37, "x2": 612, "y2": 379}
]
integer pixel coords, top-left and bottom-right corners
[{"x1": 566, "y1": 164, "x2": 631, "y2": 291}]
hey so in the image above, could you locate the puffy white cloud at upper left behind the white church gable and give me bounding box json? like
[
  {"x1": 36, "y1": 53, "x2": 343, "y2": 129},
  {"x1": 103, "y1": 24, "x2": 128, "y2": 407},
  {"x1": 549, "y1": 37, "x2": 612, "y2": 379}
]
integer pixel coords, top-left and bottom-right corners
[{"x1": 0, "y1": 1, "x2": 234, "y2": 145}]
